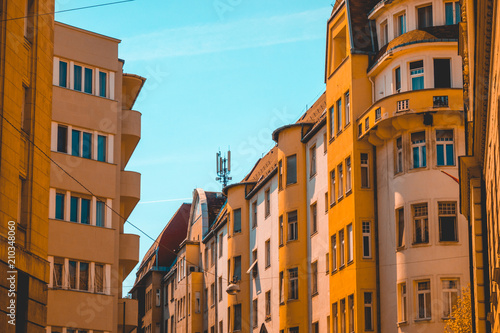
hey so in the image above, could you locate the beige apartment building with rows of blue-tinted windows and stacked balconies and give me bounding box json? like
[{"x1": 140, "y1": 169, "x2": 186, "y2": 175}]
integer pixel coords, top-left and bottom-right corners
[{"x1": 47, "y1": 22, "x2": 145, "y2": 333}]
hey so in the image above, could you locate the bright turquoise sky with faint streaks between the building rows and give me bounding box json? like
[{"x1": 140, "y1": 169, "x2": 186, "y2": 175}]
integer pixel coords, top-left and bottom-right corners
[{"x1": 56, "y1": 0, "x2": 332, "y2": 292}]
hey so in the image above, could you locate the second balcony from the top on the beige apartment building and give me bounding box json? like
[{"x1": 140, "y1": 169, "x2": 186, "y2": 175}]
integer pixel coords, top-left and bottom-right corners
[{"x1": 121, "y1": 110, "x2": 141, "y2": 168}]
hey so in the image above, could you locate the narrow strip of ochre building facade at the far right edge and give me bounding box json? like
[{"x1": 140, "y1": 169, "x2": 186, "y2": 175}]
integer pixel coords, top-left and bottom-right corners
[{"x1": 460, "y1": 1, "x2": 500, "y2": 332}]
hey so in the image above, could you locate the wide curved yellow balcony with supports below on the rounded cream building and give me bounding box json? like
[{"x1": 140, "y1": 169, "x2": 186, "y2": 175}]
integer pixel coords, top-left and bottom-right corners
[{"x1": 357, "y1": 88, "x2": 463, "y2": 144}]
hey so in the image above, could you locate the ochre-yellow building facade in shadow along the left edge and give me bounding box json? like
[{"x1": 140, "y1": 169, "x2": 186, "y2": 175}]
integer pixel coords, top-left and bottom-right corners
[{"x1": 0, "y1": 0, "x2": 54, "y2": 332}]
